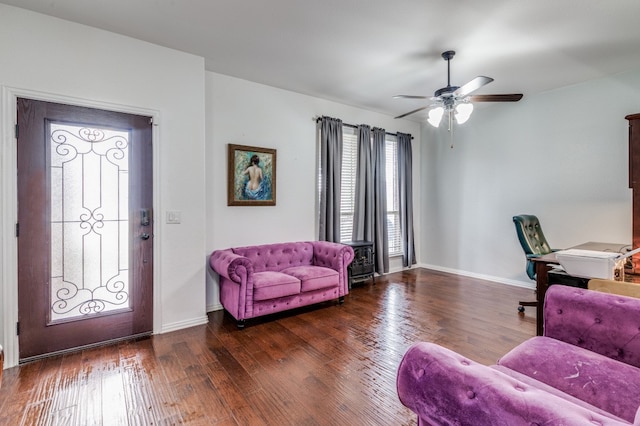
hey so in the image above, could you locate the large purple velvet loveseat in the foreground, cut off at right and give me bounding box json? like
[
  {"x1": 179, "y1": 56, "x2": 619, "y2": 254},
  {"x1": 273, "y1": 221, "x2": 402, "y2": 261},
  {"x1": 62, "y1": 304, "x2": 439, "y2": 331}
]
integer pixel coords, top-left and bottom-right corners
[{"x1": 397, "y1": 285, "x2": 640, "y2": 426}]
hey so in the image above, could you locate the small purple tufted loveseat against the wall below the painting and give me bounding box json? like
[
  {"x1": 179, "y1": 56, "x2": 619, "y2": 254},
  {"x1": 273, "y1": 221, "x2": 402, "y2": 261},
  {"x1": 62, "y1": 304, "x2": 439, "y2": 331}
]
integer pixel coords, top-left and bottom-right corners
[{"x1": 209, "y1": 241, "x2": 353, "y2": 328}]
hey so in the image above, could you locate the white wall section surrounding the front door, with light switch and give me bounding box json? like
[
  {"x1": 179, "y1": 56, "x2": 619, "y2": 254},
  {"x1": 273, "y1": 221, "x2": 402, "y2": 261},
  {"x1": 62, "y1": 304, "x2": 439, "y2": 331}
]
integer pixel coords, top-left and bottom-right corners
[{"x1": 0, "y1": 4, "x2": 207, "y2": 365}]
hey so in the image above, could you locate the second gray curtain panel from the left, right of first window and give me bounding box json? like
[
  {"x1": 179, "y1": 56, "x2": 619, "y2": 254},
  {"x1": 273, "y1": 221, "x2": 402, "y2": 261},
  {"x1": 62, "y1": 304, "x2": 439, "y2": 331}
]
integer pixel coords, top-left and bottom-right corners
[{"x1": 352, "y1": 124, "x2": 374, "y2": 241}]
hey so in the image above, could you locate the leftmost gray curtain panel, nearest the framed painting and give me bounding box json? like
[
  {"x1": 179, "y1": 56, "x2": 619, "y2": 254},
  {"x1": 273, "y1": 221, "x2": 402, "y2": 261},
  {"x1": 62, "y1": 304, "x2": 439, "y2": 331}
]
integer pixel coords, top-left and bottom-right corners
[{"x1": 318, "y1": 117, "x2": 342, "y2": 243}]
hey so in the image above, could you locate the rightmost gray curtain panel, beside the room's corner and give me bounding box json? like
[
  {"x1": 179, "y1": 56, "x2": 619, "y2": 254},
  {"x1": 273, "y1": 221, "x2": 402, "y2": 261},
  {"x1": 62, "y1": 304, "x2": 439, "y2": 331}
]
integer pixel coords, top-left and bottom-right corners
[{"x1": 398, "y1": 132, "x2": 416, "y2": 267}]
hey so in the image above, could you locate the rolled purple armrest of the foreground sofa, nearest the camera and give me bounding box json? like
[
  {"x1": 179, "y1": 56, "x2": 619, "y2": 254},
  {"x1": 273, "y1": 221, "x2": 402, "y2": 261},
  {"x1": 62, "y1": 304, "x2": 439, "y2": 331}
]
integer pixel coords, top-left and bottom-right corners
[{"x1": 396, "y1": 342, "x2": 624, "y2": 426}]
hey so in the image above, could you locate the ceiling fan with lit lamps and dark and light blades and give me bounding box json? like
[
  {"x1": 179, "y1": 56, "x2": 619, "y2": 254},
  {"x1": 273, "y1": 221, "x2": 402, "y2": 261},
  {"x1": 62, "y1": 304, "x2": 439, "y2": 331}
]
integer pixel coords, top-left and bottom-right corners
[{"x1": 394, "y1": 50, "x2": 522, "y2": 126}]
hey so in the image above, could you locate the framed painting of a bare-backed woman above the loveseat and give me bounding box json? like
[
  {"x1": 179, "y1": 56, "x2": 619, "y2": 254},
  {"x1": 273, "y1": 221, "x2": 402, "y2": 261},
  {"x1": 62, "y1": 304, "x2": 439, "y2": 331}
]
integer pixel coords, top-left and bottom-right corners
[{"x1": 227, "y1": 144, "x2": 276, "y2": 206}]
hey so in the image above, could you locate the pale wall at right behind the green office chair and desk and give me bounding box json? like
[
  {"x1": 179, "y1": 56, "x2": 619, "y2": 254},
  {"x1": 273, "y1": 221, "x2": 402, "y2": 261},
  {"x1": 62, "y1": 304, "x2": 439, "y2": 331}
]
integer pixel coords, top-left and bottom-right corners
[{"x1": 421, "y1": 72, "x2": 640, "y2": 286}]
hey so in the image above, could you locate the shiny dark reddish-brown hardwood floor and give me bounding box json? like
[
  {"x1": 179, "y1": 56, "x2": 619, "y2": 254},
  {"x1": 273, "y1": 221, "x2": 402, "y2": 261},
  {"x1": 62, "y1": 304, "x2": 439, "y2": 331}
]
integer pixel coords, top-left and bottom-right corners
[{"x1": 0, "y1": 269, "x2": 535, "y2": 426}]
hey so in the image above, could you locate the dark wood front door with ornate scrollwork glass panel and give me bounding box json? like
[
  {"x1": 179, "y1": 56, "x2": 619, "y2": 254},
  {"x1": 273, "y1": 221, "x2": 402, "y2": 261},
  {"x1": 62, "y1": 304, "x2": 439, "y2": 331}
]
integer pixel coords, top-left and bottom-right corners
[{"x1": 17, "y1": 99, "x2": 153, "y2": 362}]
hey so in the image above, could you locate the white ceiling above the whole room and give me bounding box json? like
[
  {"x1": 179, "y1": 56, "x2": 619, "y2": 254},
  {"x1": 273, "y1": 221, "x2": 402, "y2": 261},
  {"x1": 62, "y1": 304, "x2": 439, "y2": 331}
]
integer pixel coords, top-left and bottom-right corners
[{"x1": 5, "y1": 0, "x2": 640, "y2": 119}]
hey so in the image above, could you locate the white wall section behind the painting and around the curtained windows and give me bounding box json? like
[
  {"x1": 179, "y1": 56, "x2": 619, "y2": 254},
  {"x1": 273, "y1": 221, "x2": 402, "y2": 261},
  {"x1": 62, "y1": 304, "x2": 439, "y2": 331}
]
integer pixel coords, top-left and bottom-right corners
[{"x1": 206, "y1": 72, "x2": 420, "y2": 310}]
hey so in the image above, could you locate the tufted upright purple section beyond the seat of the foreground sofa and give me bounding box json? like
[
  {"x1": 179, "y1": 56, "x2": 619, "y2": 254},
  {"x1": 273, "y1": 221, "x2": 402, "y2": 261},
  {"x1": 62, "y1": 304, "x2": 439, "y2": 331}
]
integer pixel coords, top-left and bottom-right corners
[{"x1": 544, "y1": 285, "x2": 640, "y2": 368}]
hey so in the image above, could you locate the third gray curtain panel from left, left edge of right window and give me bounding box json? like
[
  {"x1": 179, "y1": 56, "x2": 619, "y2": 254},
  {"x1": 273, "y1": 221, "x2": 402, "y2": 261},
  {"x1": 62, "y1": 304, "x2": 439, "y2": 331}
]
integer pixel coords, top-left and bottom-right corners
[{"x1": 371, "y1": 128, "x2": 389, "y2": 274}]
